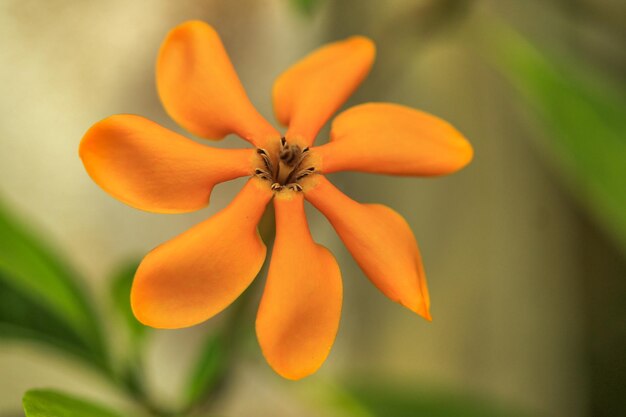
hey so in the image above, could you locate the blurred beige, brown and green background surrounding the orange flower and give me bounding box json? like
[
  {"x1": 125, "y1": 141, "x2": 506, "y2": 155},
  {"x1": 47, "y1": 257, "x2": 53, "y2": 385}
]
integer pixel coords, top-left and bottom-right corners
[{"x1": 0, "y1": 0, "x2": 626, "y2": 417}]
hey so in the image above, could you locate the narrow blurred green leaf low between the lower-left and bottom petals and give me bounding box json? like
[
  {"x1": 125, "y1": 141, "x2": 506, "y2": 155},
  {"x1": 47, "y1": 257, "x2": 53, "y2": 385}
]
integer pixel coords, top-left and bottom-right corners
[{"x1": 184, "y1": 333, "x2": 228, "y2": 405}]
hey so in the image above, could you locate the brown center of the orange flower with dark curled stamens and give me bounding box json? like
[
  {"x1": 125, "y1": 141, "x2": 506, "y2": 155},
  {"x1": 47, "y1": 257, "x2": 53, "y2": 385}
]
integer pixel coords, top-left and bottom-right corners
[{"x1": 254, "y1": 138, "x2": 315, "y2": 191}]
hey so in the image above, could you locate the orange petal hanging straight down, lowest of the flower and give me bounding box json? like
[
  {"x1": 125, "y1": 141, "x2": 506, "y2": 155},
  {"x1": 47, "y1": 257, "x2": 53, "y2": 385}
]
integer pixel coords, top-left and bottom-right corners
[{"x1": 256, "y1": 191, "x2": 342, "y2": 379}]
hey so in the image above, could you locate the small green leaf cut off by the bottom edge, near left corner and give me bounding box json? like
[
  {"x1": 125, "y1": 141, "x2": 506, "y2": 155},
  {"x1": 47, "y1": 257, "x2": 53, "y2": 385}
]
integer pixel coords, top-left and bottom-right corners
[{"x1": 22, "y1": 390, "x2": 122, "y2": 417}]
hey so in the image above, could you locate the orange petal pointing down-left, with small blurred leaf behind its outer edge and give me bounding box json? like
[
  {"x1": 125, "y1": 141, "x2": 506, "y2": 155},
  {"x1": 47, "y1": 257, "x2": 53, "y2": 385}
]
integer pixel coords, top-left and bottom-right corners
[{"x1": 131, "y1": 178, "x2": 272, "y2": 329}]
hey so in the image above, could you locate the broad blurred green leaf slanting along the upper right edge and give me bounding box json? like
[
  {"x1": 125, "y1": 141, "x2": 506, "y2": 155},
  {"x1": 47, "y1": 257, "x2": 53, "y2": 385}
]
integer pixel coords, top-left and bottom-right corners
[{"x1": 483, "y1": 21, "x2": 626, "y2": 251}]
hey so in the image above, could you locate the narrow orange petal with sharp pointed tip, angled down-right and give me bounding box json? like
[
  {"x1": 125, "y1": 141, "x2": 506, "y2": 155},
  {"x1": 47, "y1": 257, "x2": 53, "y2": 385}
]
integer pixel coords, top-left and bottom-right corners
[{"x1": 306, "y1": 176, "x2": 431, "y2": 320}]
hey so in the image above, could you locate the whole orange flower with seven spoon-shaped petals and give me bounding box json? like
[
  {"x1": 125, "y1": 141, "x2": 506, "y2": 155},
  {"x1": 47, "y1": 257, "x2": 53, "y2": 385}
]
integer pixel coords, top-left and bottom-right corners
[{"x1": 80, "y1": 21, "x2": 472, "y2": 379}]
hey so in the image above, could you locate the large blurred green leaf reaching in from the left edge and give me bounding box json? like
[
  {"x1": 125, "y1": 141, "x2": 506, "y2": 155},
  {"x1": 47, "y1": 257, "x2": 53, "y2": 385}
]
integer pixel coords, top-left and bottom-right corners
[{"x1": 0, "y1": 200, "x2": 106, "y2": 366}]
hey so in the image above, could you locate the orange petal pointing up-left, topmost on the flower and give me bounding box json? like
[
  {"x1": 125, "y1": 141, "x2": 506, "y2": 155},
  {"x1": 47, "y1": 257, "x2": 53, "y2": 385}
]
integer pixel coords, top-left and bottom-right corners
[{"x1": 156, "y1": 21, "x2": 280, "y2": 147}]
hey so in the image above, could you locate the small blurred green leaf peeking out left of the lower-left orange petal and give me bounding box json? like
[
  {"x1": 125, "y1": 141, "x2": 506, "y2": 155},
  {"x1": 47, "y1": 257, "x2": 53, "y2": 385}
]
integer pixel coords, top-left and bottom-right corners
[{"x1": 110, "y1": 261, "x2": 149, "y2": 344}]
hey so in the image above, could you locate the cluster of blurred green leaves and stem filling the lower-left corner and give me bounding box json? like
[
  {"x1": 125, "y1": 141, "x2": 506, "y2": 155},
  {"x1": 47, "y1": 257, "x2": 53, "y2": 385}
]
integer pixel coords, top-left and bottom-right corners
[{"x1": 0, "y1": 196, "x2": 254, "y2": 417}]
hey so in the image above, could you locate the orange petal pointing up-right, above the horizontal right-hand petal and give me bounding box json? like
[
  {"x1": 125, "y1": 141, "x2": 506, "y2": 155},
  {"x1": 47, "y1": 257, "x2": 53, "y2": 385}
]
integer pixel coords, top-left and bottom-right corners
[{"x1": 274, "y1": 36, "x2": 376, "y2": 146}]
